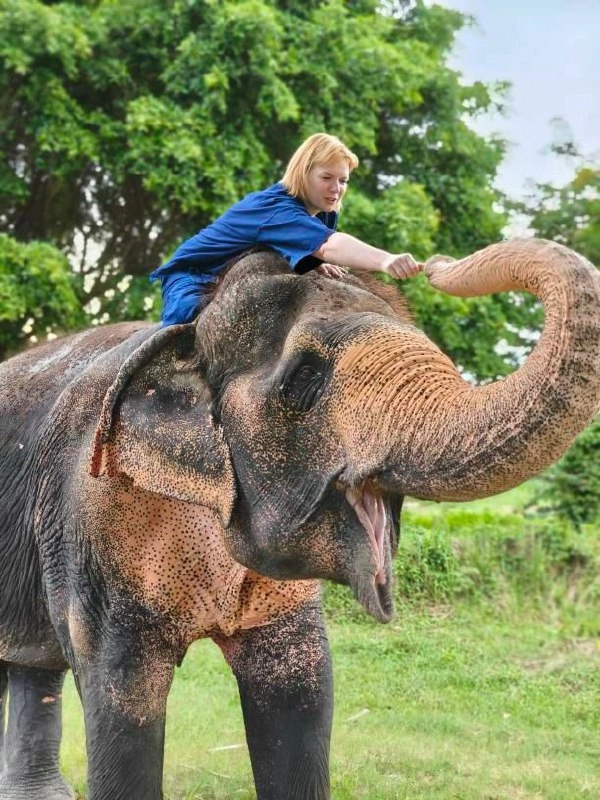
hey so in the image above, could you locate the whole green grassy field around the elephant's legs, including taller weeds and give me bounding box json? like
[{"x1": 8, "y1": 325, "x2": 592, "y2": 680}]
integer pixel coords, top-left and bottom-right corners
[{"x1": 57, "y1": 490, "x2": 600, "y2": 800}]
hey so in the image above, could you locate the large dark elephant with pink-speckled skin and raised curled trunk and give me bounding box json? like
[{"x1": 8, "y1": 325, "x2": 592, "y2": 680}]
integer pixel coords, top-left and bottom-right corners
[{"x1": 0, "y1": 239, "x2": 600, "y2": 800}]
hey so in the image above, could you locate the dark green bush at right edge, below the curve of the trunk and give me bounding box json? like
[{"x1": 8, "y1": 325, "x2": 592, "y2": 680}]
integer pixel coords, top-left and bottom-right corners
[{"x1": 532, "y1": 419, "x2": 600, "y2": 528}]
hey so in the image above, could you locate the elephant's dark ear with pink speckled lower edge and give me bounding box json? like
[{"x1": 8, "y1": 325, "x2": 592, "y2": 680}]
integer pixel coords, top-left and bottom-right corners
[{"x1": 90, "y1": 325, "x2": 235, "y2": 526}]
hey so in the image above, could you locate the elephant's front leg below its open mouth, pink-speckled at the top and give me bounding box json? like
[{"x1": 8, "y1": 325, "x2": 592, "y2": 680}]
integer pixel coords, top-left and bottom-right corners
[{"x1": 218, "y1": 603, "x2": 333, "y2": 800}]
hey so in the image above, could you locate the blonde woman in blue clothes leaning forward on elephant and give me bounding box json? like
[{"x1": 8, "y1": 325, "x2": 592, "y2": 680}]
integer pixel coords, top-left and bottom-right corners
[{"x1": 150, "y1": 133, "x2": 420, "y2": 325}]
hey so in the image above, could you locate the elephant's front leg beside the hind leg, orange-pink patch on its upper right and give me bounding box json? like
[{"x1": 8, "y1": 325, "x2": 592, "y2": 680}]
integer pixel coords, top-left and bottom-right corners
[{"x1": 76, "y1": 631, "x2": 174, "y2": 800}]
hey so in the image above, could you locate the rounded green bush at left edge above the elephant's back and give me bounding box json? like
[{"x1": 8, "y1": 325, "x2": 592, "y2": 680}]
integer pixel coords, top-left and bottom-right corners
[{"x1": 0, "y1": 234, "x2": 84, "y2": 358}]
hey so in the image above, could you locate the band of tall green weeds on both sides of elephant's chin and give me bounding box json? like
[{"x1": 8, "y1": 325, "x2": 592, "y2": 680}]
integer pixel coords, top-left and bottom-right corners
[{"x1": 325, "y1": 506, "x2": 600, "y2": 636}]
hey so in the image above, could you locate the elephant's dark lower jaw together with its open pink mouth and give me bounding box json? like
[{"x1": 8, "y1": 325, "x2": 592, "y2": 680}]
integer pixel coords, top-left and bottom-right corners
[{"x1": 223, "y1": 480, "x2": 401, "y2": 623}]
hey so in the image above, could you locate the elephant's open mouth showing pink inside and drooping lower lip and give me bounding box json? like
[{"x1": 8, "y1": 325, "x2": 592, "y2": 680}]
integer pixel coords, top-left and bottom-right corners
[{"x1": 345, "y1": 484, "x2": 394, "y2": 622}]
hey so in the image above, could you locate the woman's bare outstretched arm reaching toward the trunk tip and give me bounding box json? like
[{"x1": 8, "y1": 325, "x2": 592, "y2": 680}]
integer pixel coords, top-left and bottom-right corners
[{"x1": 313, "y1": 232, "x2": 421, "y2": 278}]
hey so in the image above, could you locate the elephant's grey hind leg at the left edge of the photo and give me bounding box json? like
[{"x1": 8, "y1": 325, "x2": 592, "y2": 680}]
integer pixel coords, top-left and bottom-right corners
[{"x1": 0, "y1": 666, "x2": 73, "y2": 800}]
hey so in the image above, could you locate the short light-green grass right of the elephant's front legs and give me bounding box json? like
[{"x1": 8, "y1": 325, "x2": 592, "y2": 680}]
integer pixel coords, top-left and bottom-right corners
[{"x1": 333, "y1": 613, "x2": 600, "y2": 800}]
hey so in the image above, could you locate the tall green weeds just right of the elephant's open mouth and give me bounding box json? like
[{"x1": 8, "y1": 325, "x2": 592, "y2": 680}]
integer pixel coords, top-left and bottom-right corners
[{"x1": 396, "y1": 512, "x2": 600, "y2": 620}]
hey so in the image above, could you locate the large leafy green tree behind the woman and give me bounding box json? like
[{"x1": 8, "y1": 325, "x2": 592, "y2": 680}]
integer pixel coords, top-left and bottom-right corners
[{"x1": 0, "y1": 0, "x2": 530, "y2": 378}]
